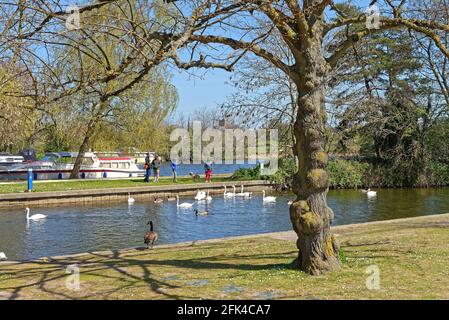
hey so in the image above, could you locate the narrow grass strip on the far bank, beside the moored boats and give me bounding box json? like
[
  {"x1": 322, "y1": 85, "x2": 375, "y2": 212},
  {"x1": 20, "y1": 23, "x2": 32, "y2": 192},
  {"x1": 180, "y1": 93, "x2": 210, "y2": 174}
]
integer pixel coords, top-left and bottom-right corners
[{"x1": 0, "y1": 176, "x2": 238, "y2": 194}]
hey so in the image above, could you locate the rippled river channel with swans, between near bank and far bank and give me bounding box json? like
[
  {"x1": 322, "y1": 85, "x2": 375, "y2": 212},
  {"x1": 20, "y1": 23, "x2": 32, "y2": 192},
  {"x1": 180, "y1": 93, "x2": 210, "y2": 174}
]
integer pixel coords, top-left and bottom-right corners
[{"x1": 0, "y1": 189, "x2": 449, "y2": 260}]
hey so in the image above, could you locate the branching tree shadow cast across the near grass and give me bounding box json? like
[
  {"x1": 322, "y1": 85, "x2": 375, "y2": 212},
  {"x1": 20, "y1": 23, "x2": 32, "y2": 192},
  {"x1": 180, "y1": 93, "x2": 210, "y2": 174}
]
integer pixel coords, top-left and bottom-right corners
[{"x1": 0, "y1": 248, "x2": 296, "y2": 300}]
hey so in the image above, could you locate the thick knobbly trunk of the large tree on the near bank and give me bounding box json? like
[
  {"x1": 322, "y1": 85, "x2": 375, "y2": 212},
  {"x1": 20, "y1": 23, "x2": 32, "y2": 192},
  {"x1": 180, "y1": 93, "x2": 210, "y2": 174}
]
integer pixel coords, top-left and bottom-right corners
[{"x1": 290, "y1": 22, "x2": 340, "y2": 275}]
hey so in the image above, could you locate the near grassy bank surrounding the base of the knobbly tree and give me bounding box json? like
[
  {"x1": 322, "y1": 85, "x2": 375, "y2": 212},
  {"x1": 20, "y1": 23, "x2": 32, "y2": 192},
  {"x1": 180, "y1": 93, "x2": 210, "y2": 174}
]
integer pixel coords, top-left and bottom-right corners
[{"x1": 0, "y1": 215, "x2": 449, "y2": 299}]
